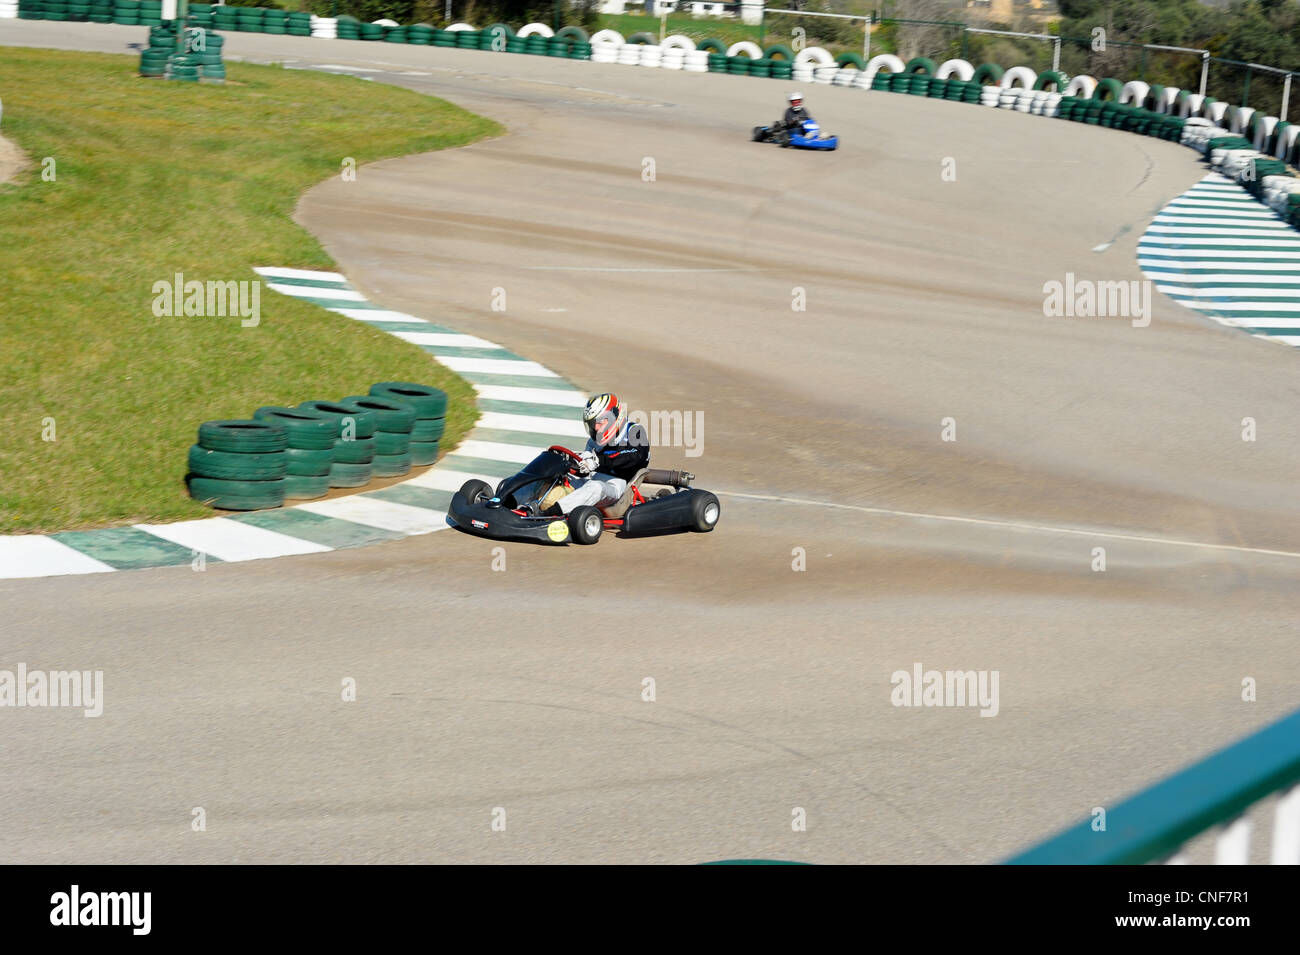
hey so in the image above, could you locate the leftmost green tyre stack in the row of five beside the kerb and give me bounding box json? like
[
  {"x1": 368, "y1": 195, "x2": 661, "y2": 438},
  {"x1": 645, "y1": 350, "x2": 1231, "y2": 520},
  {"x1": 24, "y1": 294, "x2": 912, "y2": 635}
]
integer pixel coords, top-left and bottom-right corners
[{"x1": 186, "y1": 420, "x2": 289, "y2": 511}]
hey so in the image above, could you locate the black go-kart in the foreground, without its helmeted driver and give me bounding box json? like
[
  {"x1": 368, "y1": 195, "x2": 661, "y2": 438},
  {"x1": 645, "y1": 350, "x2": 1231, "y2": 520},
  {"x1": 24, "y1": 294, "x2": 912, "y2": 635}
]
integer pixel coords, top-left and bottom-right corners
[{"x1": 447, "y1": 444, "x2": 722, "y2": 544}]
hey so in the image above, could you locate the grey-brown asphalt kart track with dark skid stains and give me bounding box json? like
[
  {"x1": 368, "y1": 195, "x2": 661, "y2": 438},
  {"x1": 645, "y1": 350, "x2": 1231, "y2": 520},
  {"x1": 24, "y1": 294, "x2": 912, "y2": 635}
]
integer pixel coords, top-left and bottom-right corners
[{"x1": 0, "y1": 21, "x2": 1300, "y2": 863}]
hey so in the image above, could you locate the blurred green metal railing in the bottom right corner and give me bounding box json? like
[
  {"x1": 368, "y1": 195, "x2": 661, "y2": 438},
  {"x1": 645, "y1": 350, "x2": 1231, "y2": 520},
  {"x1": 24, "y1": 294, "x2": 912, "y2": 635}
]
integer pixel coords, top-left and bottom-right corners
[{"x1": 1006, "y1": 711, "x2": 1300, "y2": 865}]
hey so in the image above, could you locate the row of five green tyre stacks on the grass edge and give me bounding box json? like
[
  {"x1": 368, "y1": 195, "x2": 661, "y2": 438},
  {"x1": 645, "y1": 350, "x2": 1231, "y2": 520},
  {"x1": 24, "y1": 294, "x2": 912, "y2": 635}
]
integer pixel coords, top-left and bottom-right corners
[{"x1": 186, "y1": 382, "x2": 447, "y2": 511}]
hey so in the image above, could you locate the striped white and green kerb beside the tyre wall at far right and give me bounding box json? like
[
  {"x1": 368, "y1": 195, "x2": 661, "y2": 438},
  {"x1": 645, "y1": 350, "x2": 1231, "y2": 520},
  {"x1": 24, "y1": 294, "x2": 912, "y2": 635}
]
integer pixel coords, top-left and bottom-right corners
[{"x1": 1138, "y1": 173, "x2": 1300, "y2": 346}]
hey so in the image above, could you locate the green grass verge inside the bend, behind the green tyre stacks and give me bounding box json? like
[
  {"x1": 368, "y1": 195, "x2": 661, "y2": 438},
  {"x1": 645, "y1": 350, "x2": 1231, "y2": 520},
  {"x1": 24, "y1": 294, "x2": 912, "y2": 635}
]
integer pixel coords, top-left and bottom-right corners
[{"x1": 0, "y1": 47, "x2": 502, "y2": 534}]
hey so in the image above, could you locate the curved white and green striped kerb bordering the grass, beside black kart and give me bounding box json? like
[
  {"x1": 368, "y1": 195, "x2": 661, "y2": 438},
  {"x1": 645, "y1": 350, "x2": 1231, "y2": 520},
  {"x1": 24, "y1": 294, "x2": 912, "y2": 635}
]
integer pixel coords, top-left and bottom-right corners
[{"x1": 0, "y1": 269, "x2": 586, "y2": 578}]
